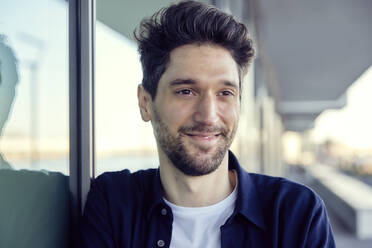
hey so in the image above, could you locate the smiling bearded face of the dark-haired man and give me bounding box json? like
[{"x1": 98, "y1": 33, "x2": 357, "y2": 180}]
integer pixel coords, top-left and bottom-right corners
[{"x1": 138, "y1": 45, "x2": 240, "y2": 176}]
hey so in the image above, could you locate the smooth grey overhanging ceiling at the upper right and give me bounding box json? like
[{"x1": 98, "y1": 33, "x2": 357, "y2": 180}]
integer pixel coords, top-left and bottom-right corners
[{"x1": 256, "y1": 0, "x2": 372, "y2": 131}]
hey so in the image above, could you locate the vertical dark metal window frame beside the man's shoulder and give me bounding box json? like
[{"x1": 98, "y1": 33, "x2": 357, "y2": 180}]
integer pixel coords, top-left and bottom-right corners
[{"x1": 68, "y1": 0, "x2": 96, "y2": 236}]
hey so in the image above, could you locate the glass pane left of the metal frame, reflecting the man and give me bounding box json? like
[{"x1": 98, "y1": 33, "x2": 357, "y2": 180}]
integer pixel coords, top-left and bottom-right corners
[{"x1": 0, "y1": 0, "x2": 69, "y2": 248}]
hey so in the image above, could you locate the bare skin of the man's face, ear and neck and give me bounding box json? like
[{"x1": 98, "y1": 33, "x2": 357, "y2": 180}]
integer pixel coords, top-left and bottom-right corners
[{"x1": 138, "y1": 44, "x2": 240, "y2": 207}]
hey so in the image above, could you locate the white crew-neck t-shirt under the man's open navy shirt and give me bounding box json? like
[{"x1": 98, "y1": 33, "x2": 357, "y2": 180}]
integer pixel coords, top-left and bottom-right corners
[{"x1": 164, "y1": 181, "x2": 237, "y2": 248}]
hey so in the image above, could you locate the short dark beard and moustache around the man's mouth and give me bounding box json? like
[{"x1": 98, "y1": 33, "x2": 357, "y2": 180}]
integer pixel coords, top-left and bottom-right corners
[{"x1": 153, "y1": 108, "x2": 236, "y2": 176}]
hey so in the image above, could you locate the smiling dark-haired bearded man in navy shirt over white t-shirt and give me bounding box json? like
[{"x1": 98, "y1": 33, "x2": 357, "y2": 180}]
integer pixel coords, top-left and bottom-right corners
[{"x1": 81, "y1": 1, "x2": 335, "y2": 248}]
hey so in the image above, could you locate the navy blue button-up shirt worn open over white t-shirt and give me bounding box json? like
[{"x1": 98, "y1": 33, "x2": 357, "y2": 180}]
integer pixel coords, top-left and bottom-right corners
[{"x1": 81, "y1": 152, "x2": 335, "y2": 248}]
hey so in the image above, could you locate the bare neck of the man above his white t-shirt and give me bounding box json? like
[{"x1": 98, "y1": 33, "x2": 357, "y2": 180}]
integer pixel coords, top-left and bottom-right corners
[{"x1": 159, "y1": 153, "x2": 236, "y2": 207}]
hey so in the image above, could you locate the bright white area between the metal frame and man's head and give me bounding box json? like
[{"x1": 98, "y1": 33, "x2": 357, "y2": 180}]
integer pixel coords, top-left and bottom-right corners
[{"x1": 96, "y1": 22, "x2": 158, "y2": 176}]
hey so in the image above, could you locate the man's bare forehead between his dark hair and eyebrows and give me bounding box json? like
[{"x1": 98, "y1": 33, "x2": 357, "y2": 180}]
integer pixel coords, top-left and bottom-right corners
[{"x1": 160, "y1": 44, "x2": 239, "y2": 86}]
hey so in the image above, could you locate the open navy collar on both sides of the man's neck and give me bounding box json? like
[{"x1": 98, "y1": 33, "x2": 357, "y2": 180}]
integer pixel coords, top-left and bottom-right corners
[{"x1": 146, "y1": 151, "x2": 266, "y2": 229}]
